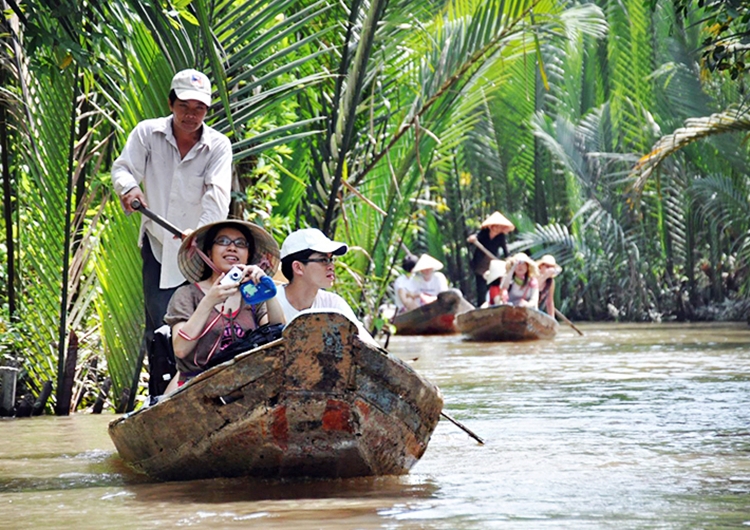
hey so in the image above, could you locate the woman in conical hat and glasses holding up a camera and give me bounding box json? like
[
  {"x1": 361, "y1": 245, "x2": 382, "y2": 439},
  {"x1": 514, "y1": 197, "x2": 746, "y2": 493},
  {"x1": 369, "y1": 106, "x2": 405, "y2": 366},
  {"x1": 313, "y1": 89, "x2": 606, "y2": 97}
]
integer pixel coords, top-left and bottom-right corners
[{"x1": 164, "y1": 220, "x2": 285, "y2": 386}]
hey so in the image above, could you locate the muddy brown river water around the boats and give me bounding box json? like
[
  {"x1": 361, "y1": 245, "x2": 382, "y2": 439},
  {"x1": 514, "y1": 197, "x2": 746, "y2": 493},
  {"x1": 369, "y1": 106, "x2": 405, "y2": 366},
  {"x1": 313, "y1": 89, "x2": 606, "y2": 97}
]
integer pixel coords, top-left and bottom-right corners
[{"x1": 0, "y1": 324, "x2": 750, "y2": 530}]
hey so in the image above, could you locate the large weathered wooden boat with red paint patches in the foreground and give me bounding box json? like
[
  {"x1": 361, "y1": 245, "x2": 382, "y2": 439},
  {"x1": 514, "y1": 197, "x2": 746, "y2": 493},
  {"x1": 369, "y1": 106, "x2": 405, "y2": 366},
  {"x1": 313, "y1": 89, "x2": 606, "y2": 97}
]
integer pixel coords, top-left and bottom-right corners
[{"x1": 109, "y1": 312, "x2": 443, "y2": 480}]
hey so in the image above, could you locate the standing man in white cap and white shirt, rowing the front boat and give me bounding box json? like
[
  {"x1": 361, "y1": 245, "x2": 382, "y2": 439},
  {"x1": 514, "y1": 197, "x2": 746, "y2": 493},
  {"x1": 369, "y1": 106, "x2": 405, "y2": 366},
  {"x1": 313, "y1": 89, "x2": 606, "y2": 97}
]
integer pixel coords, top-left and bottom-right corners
[{"x1": 112, "y1": 69, "x2": 232, "y2": 376}]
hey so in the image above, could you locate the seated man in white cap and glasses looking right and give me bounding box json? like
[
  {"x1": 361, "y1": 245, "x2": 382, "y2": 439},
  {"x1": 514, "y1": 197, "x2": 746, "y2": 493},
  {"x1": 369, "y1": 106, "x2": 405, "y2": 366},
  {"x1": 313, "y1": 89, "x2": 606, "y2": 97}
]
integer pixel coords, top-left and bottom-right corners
[{"x1": 276, "y1": 228, "x2": 379, "y2": 346}]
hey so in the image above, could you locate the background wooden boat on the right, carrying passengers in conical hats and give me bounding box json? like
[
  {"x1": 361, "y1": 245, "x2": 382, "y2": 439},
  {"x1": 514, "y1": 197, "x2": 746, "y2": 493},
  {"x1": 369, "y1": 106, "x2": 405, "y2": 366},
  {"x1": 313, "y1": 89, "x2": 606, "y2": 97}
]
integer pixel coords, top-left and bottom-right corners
[{"x1": 456, "y1": 305, "x2": 559, "y2": 341}]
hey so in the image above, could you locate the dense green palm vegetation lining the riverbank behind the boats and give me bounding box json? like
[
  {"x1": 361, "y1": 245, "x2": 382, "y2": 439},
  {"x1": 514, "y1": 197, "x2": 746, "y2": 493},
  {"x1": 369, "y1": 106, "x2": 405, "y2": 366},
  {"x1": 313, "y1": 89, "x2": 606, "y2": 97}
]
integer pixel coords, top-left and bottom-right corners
[{"x1": 0, "y1": 0, "x2": 750, "y2": 408}]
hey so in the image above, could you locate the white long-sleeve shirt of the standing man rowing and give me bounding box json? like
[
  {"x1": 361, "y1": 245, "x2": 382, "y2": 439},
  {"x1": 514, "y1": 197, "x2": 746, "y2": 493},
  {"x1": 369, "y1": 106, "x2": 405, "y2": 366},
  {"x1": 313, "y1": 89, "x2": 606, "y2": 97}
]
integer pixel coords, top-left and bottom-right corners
[{"x1": 112, "y1": 116, "x2": 232, "y2": 289}]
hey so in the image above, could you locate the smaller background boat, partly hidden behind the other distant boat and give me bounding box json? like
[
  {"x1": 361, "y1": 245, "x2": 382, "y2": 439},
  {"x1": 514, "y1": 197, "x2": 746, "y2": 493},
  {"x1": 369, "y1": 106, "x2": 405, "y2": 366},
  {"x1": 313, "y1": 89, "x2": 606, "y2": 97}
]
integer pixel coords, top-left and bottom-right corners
[{"x1": 391, "y1": 291, "x2": 474, "y2": 335}]
